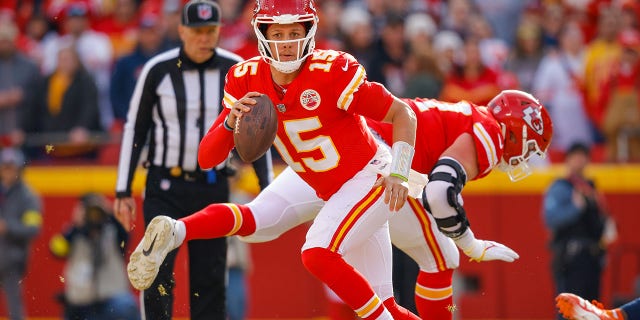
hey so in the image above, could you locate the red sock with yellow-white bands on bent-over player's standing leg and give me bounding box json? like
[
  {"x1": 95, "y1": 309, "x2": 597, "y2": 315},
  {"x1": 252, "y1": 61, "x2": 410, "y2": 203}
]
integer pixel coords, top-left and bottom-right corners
[{"x1": 416, "y1": 269, "x2": 455, "y2": 320}]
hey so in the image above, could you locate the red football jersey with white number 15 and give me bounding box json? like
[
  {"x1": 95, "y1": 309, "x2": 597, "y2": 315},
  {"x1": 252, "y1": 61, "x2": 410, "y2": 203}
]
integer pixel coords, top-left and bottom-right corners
[{"x1": 223, "y1": 50, "x2": 393, "y2": 199}]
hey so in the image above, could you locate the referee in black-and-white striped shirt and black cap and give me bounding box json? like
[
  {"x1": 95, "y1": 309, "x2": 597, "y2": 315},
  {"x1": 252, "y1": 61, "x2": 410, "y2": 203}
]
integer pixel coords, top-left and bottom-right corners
[{"x1": 114, "y1": 0, "x2": 272, "y2": 320}]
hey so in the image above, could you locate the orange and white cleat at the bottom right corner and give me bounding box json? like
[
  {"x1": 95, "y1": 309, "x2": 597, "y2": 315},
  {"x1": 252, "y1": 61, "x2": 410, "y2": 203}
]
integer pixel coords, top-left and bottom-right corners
[{"x1": 556, "y1": 293, "x2": 614, "y2": 320}]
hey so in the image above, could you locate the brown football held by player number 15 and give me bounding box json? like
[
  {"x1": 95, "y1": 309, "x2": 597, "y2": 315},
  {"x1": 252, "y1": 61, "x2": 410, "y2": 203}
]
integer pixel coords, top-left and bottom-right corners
[{"x1": 233, "y1": 94, "x2": 278, "y2": 162}]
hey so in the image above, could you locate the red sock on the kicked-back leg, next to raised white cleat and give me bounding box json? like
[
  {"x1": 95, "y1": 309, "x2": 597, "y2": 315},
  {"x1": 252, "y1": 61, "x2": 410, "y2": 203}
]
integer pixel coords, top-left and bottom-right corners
[{"x1": 180, "y1": 203, "x2": 256, "y2": 241}]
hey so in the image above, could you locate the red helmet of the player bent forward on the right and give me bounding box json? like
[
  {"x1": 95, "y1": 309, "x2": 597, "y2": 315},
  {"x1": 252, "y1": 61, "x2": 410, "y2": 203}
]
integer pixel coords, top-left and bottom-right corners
[{"x1": 487, "y1": 90, "x2": 553, "y2": 181}]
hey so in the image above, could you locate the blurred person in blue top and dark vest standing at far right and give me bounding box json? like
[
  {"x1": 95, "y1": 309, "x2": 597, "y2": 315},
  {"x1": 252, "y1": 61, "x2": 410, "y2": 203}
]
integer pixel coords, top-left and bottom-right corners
[{"x1": 543, "y1": 143, "x2": 617, "y2": 312}]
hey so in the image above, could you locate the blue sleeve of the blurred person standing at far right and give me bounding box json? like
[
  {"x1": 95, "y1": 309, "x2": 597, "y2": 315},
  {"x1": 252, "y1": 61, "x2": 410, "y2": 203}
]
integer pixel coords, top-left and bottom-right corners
[{"x1": 544, "y1": 181, "x2": 581, "y2": 230}]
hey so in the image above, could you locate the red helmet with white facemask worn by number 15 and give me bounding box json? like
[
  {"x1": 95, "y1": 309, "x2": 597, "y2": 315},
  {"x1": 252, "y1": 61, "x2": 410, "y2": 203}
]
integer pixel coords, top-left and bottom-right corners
[{"x1": 251, "y1": 0, "x2": 318, "y2": 73}]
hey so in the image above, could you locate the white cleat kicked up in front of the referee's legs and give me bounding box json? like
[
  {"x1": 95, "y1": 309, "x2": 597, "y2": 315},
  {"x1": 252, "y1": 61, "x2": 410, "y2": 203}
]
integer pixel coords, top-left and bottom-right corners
[{"x1": 127, "y1": 216, "x2": 178, "y2": 290}]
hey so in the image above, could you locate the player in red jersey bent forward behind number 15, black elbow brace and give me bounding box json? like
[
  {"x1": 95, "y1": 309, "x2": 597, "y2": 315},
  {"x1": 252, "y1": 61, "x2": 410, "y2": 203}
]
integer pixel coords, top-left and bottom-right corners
[{"x1": 229, "y1": 90, "x2": 553, "y2": 320}]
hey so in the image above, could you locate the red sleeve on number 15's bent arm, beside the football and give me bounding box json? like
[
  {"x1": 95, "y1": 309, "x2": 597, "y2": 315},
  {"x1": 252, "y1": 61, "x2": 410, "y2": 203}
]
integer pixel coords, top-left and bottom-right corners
[{"x1": 198, "y1": 108, "x2": 236, "y2": 173}]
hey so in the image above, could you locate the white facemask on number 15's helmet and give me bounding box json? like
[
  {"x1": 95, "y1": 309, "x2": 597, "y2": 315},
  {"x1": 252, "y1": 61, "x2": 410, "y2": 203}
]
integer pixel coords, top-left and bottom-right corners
[{"x1": 253, "y1": 14, "x2": 318, "y2": 73}]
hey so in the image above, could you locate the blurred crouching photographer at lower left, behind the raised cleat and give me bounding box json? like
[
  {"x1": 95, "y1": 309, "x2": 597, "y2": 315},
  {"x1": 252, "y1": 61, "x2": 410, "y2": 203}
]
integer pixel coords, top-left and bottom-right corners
[{"x1": 50, "y1": 193, "x2": 140, "y2": 320}]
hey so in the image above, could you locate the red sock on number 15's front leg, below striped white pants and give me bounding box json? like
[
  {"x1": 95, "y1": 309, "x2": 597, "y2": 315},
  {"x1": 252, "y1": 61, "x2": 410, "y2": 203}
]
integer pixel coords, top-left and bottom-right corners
[{"x1": 302, "y1": 248, "x2": 385, "y2": 319}]
